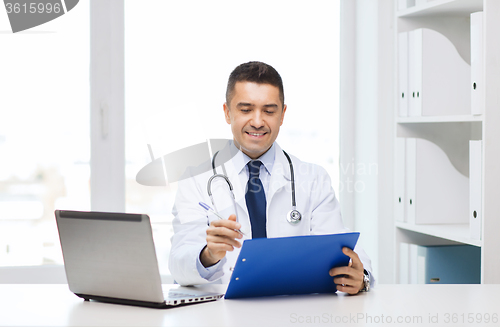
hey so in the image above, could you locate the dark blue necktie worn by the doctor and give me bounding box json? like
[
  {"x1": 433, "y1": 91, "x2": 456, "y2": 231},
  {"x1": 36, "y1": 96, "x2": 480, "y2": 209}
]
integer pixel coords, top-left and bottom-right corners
[{"x1": 245, "y1": 160, "x2": 267, "y2": 238}]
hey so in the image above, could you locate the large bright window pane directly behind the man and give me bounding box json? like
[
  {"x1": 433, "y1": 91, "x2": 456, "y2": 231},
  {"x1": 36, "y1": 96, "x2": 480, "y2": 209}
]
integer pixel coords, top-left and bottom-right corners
[{"x1": 125, "y1": 0, "x2": 340, "y2": 271}]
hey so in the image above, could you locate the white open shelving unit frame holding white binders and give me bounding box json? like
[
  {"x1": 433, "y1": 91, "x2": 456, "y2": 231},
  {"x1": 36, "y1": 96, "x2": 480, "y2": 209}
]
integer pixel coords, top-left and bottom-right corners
[{"x1": 393, "y1": 0, "x2": 500, "y2": 283}]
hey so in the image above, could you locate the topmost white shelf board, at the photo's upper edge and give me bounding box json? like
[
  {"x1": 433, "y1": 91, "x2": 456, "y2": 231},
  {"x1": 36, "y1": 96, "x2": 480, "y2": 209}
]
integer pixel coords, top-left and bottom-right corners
[{"x1": 397, "y1": 0, "x2": 483, "y2": 18}]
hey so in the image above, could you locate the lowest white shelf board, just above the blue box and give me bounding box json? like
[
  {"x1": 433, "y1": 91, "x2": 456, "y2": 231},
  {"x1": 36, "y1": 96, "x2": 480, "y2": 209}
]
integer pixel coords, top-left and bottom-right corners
[{"x1": 396, "y1": 222, "x2": 482, "y2": 247}]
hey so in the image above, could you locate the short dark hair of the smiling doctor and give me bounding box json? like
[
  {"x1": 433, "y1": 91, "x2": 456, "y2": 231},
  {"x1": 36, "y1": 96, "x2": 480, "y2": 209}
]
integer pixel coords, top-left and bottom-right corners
[{"x1": 226, "y1": 61, "x2": 285, "y2": 107}]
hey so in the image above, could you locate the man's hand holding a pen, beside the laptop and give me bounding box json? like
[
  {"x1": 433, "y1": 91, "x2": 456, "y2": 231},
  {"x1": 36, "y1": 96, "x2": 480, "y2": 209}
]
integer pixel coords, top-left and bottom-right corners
[{"x1": 200, "y1": 215, "x2": 243, "y2": 267}]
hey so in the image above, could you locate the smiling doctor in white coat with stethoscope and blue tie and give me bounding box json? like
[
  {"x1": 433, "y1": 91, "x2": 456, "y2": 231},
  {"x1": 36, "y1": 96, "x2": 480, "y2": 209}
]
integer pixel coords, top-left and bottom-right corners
[{"x1": 169, "y1": 62, "x2": 373, "y2": 294}]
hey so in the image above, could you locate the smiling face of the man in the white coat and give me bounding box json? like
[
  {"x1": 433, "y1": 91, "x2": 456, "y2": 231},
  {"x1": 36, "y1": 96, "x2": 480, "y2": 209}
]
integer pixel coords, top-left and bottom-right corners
[{"x1": 224, "y1": 82, "x2": 286, "y2": 159}]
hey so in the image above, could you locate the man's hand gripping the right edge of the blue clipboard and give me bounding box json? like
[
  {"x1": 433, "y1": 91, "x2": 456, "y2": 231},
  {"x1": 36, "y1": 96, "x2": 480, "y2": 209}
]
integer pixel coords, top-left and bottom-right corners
[{"x1": 330, "y1": 247, "x2": 364, "y2": 294}]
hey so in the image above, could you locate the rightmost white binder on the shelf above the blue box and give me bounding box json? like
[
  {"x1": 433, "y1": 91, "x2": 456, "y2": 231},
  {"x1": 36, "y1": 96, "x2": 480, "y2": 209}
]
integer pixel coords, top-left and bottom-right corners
[{"x1": 469, "y1": 141, "x2": 483, "y2": 240}]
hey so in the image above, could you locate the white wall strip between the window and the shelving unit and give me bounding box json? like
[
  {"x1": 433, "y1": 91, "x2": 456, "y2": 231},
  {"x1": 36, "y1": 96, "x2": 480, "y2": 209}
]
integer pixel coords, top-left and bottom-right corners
[{"x1": 340, "y1": 0, "x2": 394, "y2": 283}]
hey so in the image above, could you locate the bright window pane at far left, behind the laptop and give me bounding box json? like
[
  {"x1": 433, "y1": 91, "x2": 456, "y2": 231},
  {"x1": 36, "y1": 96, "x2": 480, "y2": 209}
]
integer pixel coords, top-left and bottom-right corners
[{"x1": 0, "y1": 1, "x2": 90, "y2": 266}]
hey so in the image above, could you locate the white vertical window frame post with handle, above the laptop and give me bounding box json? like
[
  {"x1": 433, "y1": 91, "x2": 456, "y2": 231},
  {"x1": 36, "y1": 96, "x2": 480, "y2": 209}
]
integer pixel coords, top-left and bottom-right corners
[{"x1": 90, "y1": 0, "x2": 125, "y2": 212}]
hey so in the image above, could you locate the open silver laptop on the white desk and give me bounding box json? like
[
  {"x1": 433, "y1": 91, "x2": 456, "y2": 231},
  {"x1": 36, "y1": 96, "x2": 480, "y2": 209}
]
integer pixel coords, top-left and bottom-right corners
[{"x1": 55, "y1": 210, "x2": 224, "y2": 308}]
